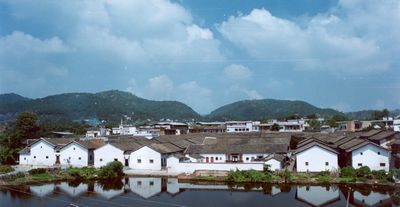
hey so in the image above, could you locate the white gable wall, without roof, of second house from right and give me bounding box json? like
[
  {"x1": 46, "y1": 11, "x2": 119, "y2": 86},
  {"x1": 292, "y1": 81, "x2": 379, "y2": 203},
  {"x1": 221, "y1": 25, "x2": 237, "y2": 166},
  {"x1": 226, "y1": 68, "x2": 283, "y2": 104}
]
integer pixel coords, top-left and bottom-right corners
[{"x1": 296, "y1": 146, "x2": 339, "y2": 172}]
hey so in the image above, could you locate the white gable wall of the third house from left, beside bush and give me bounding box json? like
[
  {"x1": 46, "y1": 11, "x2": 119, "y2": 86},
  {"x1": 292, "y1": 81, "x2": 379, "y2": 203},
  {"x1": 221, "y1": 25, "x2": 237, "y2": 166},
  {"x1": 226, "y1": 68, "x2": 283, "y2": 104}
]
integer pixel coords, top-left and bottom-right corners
[{"x1": 94, "y1": 144, "x2": 125, "y2": 167}]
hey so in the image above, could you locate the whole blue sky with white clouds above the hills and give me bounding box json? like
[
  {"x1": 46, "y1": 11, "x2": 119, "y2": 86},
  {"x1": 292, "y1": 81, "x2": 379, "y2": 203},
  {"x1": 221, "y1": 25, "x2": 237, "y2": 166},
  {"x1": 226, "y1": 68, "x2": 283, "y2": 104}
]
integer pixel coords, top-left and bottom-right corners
[{"x1": 0, "y1": 0, "x2": 400, "y2": 114}]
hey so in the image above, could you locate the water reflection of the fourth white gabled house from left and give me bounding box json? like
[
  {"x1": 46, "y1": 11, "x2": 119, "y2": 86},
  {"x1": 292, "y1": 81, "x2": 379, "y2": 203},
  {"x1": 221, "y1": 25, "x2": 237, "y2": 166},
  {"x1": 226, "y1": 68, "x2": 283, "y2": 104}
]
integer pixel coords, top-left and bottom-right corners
[{"x1": 129, "y1": 177, "x2": 161, "y2": 199}]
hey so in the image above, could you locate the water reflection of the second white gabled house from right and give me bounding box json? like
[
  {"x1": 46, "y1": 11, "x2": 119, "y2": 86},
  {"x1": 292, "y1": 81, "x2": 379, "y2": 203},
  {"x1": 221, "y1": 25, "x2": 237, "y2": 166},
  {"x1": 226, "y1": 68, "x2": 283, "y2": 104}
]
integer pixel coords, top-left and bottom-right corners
[{"x1": 296, "y1": 186, "x2": 340, "y2": 206}]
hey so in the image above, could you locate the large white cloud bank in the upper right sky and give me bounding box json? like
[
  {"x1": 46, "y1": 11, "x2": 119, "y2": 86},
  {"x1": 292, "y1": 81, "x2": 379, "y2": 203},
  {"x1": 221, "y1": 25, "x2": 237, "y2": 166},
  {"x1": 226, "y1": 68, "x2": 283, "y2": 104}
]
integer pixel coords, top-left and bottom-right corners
[{"x1": 218, "y1": 1, "x2": 400, "y2": 72}]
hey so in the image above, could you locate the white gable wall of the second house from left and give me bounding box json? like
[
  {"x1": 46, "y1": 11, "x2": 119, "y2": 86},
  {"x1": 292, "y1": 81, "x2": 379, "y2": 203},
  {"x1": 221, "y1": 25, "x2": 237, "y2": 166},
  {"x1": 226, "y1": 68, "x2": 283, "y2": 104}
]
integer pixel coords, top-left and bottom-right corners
[{"x1": 60, "y1": 143, "x2": 89, "y2": 167}]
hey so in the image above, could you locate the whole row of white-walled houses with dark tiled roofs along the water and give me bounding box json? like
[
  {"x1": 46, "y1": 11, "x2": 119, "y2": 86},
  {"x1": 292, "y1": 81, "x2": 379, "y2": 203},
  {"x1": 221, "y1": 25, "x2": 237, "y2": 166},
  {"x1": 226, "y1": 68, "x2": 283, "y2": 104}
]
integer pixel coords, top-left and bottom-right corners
[{"x1": 19, "y1": 130, "x2": 400, "y2": 173}]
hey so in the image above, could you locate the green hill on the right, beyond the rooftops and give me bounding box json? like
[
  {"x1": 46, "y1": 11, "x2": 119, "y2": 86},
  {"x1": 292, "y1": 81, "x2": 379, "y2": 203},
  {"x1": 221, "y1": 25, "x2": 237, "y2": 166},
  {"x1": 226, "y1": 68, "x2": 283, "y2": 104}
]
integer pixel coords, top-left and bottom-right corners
[{"x1": 207, "y1": 99, "x2": 343, "y2": 120}]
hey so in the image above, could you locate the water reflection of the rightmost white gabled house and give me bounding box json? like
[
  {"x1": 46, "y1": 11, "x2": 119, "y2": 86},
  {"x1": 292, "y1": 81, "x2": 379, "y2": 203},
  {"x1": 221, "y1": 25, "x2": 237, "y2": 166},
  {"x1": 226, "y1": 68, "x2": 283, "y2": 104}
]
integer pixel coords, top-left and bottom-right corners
[{"x1": 352, "y1": 191, "x2": 392, "y2": 206}]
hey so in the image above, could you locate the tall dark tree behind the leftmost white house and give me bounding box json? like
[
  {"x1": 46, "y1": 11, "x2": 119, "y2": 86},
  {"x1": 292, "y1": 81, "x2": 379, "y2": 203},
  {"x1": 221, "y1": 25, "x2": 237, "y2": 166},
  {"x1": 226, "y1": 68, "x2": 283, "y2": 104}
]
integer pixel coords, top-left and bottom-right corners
[{"x1": 11, "y1": 111, "x2": 39, "y2": 147}]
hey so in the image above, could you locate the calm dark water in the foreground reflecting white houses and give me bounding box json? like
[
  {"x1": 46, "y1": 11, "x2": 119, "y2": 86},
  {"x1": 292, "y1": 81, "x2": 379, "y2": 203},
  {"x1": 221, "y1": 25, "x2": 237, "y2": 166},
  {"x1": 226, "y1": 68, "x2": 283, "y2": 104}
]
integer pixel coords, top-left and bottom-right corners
[{"x1": 0, "y1": 177, "x2": 400, "y2": 207}]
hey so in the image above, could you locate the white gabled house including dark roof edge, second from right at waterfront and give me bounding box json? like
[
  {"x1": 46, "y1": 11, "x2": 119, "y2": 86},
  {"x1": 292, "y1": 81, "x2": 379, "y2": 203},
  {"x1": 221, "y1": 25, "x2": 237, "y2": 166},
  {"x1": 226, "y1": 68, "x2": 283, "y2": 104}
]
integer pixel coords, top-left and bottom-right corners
[{"x1": 295, "y1": 141, "x2": 339, "y2": 172}]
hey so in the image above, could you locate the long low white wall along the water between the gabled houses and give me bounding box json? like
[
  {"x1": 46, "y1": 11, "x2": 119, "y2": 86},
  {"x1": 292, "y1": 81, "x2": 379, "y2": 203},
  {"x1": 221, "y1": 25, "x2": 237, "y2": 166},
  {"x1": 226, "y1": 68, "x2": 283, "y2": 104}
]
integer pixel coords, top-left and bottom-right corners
[{"x1": 167, "y1": 157, "x2": 264, "y2": 173}]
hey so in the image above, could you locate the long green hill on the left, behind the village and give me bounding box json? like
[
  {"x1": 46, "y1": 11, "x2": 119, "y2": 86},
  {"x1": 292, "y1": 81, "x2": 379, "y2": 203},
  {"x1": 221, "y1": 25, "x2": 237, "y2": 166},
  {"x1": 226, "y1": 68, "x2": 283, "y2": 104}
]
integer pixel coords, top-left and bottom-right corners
[{"x1": 0, "y1": 90, "x2": 200, "y2": 122}]
